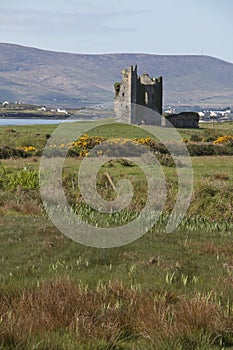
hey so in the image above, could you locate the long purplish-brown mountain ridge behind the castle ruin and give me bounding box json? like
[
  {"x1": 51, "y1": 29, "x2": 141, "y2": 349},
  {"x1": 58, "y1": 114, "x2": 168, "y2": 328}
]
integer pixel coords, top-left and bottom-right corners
[{"x1": 0, "y1": 43, "x2": 233, "y2": 107}]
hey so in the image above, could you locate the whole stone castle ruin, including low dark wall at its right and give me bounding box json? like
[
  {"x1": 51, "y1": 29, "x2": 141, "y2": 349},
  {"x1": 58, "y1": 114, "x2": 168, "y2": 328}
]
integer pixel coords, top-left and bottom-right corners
[{"x1": 114, "y1": 66, "x2": 199, "y2": 128}]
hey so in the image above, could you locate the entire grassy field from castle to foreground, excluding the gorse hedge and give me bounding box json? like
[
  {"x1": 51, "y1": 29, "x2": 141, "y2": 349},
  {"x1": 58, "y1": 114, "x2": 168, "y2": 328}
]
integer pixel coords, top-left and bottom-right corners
[{"x1": 0, "y1": 123, "x2": 233, "y2": 350}]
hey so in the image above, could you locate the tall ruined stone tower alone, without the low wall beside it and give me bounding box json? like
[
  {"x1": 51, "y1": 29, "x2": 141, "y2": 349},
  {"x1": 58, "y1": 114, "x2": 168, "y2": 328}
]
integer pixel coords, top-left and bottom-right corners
[{"x1": 114, "y1": 66, "x2": 162, "y2": 124}]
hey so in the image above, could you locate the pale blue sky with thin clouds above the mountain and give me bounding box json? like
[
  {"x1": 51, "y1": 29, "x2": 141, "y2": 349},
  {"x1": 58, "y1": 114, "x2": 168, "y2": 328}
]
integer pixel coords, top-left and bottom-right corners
[{"x1": 0, "y1": 0, "x2": 233, "y2": 63}]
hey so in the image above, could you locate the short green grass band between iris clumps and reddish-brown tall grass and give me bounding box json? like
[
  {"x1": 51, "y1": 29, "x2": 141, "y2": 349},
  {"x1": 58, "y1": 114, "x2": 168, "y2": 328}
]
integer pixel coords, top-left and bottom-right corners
[{"x1": 0, "y1": 216, "x2": 233, "y2": 297}]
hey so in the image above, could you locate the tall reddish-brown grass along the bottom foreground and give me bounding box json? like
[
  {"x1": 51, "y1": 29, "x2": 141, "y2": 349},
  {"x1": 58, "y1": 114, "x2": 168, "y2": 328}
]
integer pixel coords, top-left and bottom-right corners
[{"x1": 0, "y1": 279, "x2": 233, "y2": 349}]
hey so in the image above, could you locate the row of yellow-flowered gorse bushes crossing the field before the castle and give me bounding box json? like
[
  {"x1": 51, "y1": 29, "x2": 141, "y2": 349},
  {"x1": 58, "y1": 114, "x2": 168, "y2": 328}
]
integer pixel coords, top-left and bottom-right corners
[{"x1": 0, "y1": 133, "x2": 233, "y2": 159}]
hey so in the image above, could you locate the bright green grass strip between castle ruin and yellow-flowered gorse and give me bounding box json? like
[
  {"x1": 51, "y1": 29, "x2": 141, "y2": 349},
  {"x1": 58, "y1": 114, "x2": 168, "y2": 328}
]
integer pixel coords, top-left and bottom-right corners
[{"x1": 0, "y1": 119, "x2": 233, "y2": 149}]
